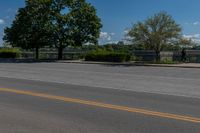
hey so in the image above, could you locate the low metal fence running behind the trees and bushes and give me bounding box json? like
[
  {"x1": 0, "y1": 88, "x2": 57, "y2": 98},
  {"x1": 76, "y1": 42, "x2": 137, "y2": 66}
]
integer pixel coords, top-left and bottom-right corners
[{"x1": 20, "y1": 49, "x2": 200, "y2": 63}]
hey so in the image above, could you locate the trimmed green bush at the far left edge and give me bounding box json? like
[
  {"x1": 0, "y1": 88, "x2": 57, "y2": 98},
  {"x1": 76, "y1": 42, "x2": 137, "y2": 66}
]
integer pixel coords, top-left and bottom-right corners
[{"x1": 0, "y1": 48, "x2": 20, "y2": 58}]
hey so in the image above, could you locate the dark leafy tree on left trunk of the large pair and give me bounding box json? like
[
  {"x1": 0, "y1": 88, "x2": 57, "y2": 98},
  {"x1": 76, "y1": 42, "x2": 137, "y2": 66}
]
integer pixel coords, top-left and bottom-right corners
[{"x1": 4, "y1": 0, "x2": 51, "y2": 59}]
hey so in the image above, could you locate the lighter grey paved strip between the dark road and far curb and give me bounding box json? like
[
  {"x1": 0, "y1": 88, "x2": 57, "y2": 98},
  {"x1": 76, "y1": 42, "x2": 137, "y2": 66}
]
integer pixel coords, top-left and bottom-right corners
[{"x1": 0, "y1": 63, "x2": 200, "y2": 98}]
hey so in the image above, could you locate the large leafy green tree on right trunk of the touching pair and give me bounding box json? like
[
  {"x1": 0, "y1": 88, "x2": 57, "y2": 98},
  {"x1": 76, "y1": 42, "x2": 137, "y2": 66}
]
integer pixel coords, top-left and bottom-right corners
[{"x1": 52, "y1": 0, "x2": 102, "y2": 59}]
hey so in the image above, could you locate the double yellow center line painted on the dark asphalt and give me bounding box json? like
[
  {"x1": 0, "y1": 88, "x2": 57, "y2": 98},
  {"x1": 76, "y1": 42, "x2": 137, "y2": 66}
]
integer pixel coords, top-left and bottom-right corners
[{"x1": 0, "y1": 88, "x2": 200, "y2": 123}]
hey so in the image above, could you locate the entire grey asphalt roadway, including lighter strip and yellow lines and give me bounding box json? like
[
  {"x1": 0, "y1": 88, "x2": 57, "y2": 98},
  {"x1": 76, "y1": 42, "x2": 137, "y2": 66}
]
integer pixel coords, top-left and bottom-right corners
[{"x1": 0, "y1": 63, "x2": 200, "y2": 133}]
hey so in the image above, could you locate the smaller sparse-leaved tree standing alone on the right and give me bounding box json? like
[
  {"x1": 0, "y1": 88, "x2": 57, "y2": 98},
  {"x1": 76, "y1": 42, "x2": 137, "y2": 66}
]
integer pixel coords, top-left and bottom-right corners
[{"x1": 127, "y1": 12, "x2": 181, "y2": 61}]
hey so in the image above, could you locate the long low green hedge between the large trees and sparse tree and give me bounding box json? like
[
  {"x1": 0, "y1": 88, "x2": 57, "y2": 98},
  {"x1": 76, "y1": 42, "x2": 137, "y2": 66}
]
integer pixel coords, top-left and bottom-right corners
[{"x1": 85, "y1": 50, "x2": 131, "y2": 62}]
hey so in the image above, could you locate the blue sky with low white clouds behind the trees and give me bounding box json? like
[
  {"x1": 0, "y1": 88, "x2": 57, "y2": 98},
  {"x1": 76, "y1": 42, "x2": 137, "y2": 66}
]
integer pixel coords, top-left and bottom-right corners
[{"x1": 0, "y1": 0, "x2": 200, "y2": 45}]
